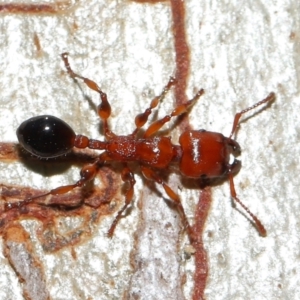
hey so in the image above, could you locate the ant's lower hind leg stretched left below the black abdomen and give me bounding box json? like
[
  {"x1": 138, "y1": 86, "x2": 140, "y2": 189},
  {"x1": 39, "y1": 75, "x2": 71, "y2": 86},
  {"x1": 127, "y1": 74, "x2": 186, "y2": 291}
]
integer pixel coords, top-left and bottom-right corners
[{"x1": 4, "y1": 152, "x2": 109, "y2": 211}]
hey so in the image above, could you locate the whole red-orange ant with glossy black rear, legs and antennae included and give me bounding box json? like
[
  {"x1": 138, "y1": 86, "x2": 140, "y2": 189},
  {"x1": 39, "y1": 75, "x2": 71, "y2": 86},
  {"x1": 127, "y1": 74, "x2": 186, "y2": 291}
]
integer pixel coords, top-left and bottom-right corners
[{"x1": 11, "y1": 53, "x2": 275, "y2": 242}]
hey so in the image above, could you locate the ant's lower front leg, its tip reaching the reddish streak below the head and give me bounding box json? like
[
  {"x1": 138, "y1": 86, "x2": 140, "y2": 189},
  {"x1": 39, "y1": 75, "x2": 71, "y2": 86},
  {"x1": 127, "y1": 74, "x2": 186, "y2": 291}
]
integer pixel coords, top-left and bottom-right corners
[{"x1": 141, "y1": 166, "x2": 194, "y2": 243}]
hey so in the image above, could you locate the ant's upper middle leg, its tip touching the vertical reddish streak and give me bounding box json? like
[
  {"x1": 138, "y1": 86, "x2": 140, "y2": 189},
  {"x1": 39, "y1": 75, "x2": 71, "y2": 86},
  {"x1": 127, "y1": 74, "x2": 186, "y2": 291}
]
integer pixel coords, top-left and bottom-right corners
[{"x1": 132, "y1": 77, "x2": 176, "y2": 135}]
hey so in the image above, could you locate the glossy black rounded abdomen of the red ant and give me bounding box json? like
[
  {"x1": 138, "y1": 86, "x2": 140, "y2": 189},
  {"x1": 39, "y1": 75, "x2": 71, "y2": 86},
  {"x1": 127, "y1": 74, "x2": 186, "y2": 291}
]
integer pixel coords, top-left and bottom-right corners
[{"x1": 17, "y1": 115, "x2": 75, "y2": 158}]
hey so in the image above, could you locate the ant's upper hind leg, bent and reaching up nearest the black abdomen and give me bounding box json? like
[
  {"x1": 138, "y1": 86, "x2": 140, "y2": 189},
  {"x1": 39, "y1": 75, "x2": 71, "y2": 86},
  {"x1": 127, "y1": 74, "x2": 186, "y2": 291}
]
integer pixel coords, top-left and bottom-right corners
[{"x1": 61, "y1": 52, "x2": 115, "y2": 139}]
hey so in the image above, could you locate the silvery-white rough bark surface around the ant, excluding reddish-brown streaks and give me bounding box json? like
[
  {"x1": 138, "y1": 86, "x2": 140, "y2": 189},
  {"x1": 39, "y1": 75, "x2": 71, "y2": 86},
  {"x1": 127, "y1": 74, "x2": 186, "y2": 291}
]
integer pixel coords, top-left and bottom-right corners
[{"x1": 0, "y1": 0, "x2": 300, "y2": 300}]
